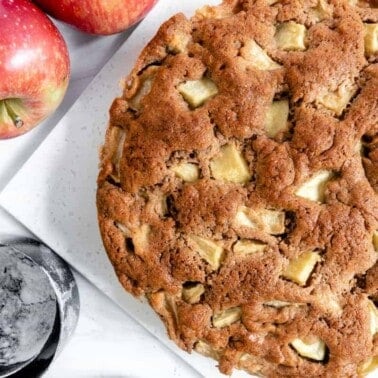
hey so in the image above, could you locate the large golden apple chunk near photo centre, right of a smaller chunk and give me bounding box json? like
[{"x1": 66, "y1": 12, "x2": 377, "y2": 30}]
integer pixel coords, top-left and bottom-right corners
[{"x1": 210, "y1": 144, "x2": 251, "y2": 184}]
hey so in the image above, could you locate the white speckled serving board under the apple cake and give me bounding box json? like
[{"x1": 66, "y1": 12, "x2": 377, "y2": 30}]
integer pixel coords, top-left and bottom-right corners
[{"x1": 0, "y1": 0, "x2": 250, "y2": 377}]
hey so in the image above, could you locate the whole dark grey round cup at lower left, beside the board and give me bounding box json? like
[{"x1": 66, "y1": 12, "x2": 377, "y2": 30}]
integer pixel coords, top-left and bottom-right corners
[{"x1": 0, "y1": 239, "x2": 80, "y2": 378}]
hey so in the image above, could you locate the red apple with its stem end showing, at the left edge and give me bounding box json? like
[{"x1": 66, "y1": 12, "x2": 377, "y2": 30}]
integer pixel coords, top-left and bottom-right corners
[{"x1": 0, "y1": 0, "x2": 70, "y2": 139}]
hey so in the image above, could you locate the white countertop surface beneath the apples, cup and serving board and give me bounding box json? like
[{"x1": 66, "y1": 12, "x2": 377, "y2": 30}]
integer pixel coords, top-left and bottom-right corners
[{"x1": 0, "y1": 22, "x2": 201, "y2": 378}]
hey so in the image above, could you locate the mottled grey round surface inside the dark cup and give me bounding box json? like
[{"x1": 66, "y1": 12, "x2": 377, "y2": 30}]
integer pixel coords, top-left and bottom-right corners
[{"x1": 0, "y1": 246, "x2": 57, "y2": 366}]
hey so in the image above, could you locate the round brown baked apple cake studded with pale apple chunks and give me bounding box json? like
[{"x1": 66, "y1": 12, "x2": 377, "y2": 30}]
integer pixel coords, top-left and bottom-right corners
[{"x1": 97, "y1": 0, "x2": 378, "y2": 378}]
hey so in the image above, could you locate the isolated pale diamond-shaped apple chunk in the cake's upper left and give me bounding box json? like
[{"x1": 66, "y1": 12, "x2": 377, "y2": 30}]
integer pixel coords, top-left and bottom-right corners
[{"x1": 177, "y1": 77, "x2": 218, "y2": 109}]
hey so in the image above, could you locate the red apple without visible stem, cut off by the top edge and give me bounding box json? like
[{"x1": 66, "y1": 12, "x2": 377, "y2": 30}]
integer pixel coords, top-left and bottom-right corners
[{"x1": 34, "y1": 0, "x2": 157, "y2": 35}]
